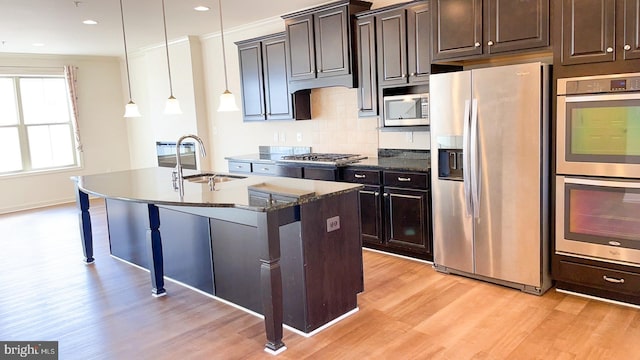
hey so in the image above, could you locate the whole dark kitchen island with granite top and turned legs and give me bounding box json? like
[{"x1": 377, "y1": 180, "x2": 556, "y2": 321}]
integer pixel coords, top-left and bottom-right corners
[{"x1": 73, "y1": 168, "x2": 363, "y2": 353}]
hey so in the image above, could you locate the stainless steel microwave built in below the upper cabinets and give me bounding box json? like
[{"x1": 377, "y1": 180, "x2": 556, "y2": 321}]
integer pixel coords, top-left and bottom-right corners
[{"x1": 383, "y1": 93, "x2": 429, "y2": 126}]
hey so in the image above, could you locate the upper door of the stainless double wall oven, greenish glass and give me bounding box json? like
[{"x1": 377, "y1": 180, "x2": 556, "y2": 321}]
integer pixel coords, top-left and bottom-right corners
[{"x1": 556, "y1": 92, "x2": 640, "y2": 178}]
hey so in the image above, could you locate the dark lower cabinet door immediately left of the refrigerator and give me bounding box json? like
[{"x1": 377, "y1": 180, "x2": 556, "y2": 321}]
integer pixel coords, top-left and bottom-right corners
[{"x1": 384, "y1": 187, "x2": 431, "y2": 253}]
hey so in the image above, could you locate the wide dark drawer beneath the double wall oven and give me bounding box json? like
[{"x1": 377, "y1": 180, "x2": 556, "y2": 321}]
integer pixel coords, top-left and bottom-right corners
[{"x1": 556, "y1": 260, "x2": 640, "y2": 296}]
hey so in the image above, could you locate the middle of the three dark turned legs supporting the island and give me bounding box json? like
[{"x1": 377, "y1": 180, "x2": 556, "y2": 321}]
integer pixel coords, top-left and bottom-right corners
[{"x1": 147, "y1": 204, "x2": 167, "y2": 297}]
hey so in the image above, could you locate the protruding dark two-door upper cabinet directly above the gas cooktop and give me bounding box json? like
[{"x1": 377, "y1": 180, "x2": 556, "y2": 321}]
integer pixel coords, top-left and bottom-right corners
[{"x1": 282, "y1": 0, "x2": 371, "y2": 91}]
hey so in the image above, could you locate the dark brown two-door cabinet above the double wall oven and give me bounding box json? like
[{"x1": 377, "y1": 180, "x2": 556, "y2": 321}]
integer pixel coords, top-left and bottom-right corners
[{"x1": 556, "y1": 0, "x2": 640, "y2": 65}]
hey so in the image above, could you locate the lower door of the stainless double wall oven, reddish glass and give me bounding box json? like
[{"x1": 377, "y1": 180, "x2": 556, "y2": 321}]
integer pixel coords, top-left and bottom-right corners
[{"x1": 556, "y1": 176, "x2": 640, "y2": 266}]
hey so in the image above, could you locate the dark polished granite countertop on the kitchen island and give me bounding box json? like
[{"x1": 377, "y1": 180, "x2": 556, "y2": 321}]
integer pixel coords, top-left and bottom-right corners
[{"x1": 73, "y1": 167, "x2": 362, "y2": 211}]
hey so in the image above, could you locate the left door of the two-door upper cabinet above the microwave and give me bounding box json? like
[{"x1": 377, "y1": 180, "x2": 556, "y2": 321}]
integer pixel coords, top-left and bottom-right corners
[{"x1": 376, "y1": 9, "x2": 407, "y2": 86}]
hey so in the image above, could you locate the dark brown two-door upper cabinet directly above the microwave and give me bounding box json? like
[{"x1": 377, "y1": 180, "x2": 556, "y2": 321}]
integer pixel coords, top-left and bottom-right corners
[{"x1": 376, "y1": 3, "x2": 431, "y2": 86}]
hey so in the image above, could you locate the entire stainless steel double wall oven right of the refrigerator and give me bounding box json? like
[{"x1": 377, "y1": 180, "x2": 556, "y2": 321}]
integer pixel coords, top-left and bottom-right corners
[{"x1": 556, "y1": 73, "x2": 640, "y2": 267}]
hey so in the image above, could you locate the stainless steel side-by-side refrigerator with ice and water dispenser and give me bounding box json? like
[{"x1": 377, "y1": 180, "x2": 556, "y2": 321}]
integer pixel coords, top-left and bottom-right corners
[{"x1": 429, "y1": 62, "x2": 551, "y2": 294}]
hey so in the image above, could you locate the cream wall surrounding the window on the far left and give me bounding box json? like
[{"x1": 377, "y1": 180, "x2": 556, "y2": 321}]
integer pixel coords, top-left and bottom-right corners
[{"x1": 0, "y1": 54, "x2": 130, "y2": 213}]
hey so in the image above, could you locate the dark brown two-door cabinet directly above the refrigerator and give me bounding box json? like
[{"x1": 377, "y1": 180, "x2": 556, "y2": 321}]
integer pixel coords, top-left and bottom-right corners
[{"x1": 431, "y1": 0, "x2": 549, "y2": 62}]
